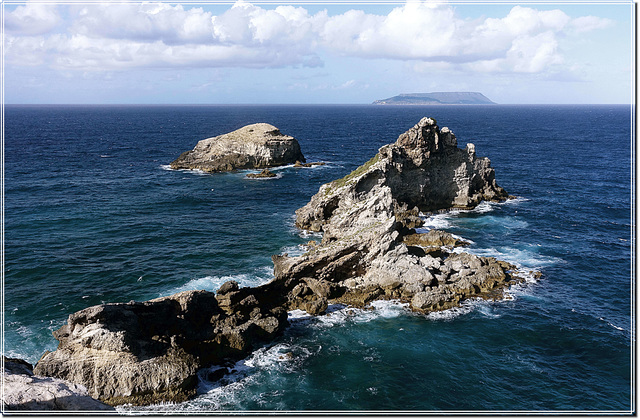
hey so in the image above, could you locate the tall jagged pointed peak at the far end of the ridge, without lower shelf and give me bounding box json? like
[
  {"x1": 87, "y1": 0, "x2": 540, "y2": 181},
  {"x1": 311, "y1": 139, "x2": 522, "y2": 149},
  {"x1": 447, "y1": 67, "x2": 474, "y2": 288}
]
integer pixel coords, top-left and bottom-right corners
[{"x1": 296, "y1": 118, "x2": 508, "y2": 232}]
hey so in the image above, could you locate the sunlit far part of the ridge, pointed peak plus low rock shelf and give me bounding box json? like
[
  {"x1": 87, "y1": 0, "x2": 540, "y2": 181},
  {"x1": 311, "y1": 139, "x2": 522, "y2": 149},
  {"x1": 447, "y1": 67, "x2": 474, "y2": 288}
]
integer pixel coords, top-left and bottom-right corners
[{"x1": 274, "y1": 118, "x2": 519, "y2": 312}]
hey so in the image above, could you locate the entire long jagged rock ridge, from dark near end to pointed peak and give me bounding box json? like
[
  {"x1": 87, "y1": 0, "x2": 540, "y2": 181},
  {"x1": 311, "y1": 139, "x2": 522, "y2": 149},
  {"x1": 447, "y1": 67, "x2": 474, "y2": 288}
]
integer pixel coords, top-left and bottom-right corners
[{"x1": 35, "y1": 118, "x2": 522, "y2": 405}]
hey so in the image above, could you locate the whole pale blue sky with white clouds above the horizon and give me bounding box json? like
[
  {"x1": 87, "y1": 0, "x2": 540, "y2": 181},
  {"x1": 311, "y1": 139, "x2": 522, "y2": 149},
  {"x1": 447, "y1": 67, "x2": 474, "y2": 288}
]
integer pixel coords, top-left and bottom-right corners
[{"x1": 2, "y1": 0, "x2": 635, "y2": 104}]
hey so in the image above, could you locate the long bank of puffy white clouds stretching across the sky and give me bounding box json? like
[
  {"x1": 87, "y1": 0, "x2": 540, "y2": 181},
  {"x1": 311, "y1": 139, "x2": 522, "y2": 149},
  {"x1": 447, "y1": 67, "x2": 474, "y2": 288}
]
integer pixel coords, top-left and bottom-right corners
[{"x1": 5, "y1": 1, "x2": 611, "y2": 73}]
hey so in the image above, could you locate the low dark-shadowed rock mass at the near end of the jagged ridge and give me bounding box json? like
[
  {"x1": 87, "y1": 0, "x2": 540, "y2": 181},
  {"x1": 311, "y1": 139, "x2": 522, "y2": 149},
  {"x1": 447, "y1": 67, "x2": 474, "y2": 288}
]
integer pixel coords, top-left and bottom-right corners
[{"x1": 35, "y1": 290, "x2": 288, "y2": 405}]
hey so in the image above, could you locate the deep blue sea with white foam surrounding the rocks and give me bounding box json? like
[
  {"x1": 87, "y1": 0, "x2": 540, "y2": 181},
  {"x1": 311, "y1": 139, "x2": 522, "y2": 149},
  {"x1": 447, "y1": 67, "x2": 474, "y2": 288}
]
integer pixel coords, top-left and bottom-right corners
[{"x1": 4, "y1": 106, "x2": 635, "y2": 412}]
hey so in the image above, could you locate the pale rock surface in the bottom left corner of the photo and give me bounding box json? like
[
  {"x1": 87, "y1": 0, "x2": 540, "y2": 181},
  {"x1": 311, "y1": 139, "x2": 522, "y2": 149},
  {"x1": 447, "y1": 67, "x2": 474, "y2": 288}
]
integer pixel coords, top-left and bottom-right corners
[{"x1": 2, "y1": 356, "x2": 115, "y2": 412}]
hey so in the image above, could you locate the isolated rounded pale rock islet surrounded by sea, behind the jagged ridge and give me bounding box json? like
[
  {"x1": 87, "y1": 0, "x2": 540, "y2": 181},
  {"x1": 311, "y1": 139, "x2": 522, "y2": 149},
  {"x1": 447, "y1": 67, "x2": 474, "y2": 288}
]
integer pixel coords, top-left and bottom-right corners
[{"x1": 170, "y1": 123, "x2": 305, "y2": 172}]
